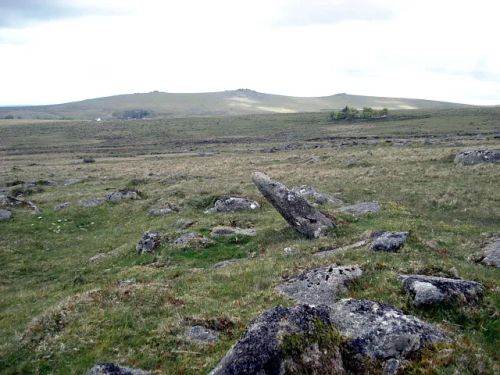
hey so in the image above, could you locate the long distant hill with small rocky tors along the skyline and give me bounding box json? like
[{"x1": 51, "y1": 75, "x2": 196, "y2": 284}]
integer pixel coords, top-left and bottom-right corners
[{"x1": 0, "y1": 89, "x2": 466, "y2": 120}]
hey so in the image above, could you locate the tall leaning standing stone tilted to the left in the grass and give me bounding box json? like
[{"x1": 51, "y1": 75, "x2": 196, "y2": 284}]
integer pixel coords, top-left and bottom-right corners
[{"x1": 252, "y1": 172, "x2": 336, "y2": 238}]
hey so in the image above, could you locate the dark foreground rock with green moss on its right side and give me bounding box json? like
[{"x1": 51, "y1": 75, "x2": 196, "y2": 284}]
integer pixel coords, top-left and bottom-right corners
[{"x1": 210, "y1": 305, "x2": 345, "y2": 375}]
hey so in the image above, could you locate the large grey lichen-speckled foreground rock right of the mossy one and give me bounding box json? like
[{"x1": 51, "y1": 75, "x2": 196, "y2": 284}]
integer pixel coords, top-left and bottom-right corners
[{"x1": 330, "y1": 299, "x2": 447, "y2": 374}]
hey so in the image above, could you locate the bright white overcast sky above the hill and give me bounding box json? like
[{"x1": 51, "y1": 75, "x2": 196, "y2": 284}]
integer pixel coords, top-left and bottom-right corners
[{"x1": 0, "y1": 0, "x2": 500, "y2": 106}]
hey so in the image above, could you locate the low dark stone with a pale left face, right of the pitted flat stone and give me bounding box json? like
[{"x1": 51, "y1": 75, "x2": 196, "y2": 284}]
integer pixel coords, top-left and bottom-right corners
[{"x1": 399, "y1": 275, "x2": 484, "y2": 307}]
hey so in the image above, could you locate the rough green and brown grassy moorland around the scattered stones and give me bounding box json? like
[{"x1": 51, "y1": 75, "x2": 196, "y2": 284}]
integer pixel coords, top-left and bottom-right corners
[{"x1": 0, "y1": 108, "x2": 500, "y2": 374}]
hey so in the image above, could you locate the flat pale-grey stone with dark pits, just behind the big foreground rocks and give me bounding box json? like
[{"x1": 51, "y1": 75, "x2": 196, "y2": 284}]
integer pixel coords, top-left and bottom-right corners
[{"x1": 276, "y1": 265, "x2": 363, "y2": 305}]
